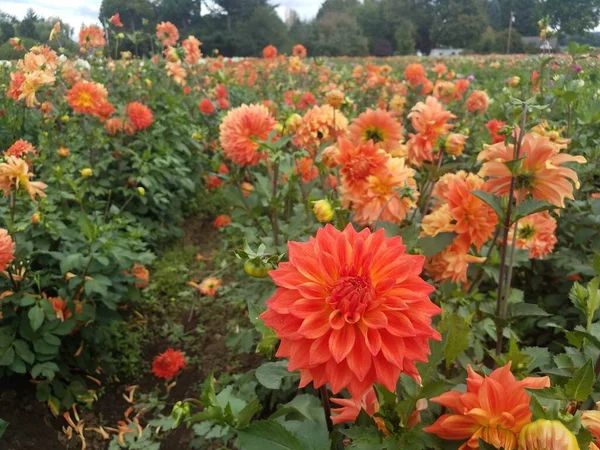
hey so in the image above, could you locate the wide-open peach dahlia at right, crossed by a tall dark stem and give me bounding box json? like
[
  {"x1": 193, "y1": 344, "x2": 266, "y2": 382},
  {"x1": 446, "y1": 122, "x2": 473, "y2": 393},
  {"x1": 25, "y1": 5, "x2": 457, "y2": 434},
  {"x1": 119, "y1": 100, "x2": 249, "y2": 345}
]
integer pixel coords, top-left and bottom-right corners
[{"x1": 477, "y1": 133, "x2": 586, "y2": 207}]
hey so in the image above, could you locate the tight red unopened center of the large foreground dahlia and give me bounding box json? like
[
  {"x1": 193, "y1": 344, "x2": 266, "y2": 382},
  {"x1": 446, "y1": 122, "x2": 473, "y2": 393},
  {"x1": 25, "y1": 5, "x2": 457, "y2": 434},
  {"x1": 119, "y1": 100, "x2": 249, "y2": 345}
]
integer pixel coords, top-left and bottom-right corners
[{"x1": 327, "y1": 275, "x2": 375, "y2": 323}]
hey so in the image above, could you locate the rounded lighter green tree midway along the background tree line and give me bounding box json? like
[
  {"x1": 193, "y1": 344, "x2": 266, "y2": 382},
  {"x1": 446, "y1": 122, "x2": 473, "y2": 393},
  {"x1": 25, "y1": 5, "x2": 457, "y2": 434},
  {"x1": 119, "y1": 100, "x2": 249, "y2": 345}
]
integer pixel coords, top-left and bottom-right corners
[{"x1": 317, "y1": 12, "x2": 369, "y2": 56}]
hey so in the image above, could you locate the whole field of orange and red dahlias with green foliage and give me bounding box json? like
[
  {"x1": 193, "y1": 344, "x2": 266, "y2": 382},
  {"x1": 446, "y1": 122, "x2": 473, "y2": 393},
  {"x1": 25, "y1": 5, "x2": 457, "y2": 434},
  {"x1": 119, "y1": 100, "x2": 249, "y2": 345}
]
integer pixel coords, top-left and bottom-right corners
[{"x1": 0, "y1": 17, "x2": 600, "y2": 450}]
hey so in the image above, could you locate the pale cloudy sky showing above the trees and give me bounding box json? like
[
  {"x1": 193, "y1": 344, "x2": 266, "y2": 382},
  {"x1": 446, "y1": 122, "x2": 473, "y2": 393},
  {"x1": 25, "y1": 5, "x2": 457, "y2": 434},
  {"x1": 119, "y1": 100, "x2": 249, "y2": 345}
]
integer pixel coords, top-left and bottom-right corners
[{"x1": 0, "y1": 0, "x2": 323, "y2": 31}]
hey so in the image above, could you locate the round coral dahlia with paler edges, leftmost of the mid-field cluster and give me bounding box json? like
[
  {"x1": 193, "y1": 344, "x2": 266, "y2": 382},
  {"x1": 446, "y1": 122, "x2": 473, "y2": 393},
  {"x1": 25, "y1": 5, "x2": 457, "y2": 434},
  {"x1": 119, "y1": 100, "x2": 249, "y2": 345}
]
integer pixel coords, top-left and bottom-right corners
[{"x1": 219, "y1": 104, "x2": 277, "y2": 166}]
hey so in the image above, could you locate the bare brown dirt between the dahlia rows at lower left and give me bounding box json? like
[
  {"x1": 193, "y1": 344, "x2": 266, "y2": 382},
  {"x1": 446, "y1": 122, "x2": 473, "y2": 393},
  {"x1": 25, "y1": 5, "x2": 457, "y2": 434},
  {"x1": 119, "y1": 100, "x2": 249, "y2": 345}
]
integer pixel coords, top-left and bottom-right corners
[{"x1": 0, "y1": 219, "x2": 260, "y2": 450}]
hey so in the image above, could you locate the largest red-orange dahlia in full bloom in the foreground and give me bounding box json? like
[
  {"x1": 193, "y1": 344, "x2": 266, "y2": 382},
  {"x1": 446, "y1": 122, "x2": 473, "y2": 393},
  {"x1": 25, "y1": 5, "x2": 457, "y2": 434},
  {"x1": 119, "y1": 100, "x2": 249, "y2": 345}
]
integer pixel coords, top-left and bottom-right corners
[{"x1": 260, "y1": 225, "x2": 441, "y2": 398}]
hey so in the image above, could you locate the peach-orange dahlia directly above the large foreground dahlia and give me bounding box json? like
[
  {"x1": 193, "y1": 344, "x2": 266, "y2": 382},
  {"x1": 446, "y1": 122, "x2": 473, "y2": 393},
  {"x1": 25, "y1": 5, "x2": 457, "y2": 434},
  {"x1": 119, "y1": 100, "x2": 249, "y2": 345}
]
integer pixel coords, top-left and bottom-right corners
[{"x1": 351, "y1": 158, "x2": 419, "y2": 225}]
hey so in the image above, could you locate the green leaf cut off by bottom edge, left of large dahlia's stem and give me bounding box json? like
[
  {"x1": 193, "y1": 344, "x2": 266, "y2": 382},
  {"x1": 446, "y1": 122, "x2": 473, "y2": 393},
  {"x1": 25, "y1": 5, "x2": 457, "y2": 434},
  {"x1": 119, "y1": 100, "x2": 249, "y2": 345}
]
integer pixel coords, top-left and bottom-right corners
[{"x1": 238, "y1": 420, "x2": 304, "y2": 450}]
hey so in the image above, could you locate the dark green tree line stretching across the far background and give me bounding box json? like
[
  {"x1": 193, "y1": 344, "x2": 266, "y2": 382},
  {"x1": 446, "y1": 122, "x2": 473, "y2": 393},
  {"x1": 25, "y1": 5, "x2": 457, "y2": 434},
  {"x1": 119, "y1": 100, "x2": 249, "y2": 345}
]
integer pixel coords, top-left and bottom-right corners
[{"x1": 0, "y1": 0, "x2": 600, "y2": 56}]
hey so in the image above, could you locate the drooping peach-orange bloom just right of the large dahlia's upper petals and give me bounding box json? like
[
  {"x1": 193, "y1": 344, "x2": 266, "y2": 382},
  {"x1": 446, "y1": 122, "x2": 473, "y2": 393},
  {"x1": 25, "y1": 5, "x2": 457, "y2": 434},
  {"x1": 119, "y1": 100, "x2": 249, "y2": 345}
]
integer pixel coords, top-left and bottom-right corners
[{"x1": 425, "y1": 240, "x2": 485, "y2": 283}]
